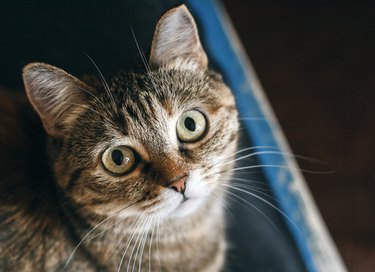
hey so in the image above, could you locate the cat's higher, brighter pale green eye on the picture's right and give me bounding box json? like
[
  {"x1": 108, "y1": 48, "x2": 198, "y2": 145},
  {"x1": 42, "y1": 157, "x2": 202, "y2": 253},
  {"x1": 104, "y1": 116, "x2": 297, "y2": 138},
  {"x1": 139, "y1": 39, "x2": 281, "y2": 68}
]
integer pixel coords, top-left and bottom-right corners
[{"x1": 176, "y1": 110, "x2": 207, "y2": 143}]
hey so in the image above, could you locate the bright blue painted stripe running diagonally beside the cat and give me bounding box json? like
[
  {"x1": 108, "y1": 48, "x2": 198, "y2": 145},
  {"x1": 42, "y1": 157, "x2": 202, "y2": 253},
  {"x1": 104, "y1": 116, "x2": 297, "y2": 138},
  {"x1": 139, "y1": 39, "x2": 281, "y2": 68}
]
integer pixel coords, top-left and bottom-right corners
[{"x1": 186, "y1": 0, "x2": 317, "y2": 272}]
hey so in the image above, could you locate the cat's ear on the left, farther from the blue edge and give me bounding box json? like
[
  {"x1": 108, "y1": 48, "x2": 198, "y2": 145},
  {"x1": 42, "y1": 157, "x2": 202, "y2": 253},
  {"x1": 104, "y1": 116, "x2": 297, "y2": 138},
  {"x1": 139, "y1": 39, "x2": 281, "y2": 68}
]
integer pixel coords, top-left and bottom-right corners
[{"x1": 22, "y1": 63, "x2": 94, "y2": 138}]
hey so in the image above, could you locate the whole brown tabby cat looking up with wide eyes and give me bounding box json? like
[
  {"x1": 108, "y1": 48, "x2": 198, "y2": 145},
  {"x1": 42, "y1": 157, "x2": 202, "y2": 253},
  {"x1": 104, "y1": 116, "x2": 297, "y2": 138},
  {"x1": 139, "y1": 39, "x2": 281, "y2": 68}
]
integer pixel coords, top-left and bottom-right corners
[{"x1": 0, "y1": 5, "x2": 239, "y2": 272}]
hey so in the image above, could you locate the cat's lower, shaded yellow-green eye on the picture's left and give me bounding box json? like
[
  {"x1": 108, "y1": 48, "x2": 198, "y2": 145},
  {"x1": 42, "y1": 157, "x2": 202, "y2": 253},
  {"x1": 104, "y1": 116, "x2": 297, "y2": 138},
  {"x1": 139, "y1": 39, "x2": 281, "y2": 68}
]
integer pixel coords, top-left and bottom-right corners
[{"x1": 102, "y1": 146, "x2": 136, "y2": 175}]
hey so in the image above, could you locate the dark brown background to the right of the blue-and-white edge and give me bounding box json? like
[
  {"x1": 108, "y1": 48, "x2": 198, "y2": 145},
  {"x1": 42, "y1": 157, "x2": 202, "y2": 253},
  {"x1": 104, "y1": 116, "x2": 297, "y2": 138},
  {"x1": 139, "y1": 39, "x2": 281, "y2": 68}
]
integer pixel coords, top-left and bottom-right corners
[{"x1": 224, "y1": 0, "x2": 375, "y2": 272}]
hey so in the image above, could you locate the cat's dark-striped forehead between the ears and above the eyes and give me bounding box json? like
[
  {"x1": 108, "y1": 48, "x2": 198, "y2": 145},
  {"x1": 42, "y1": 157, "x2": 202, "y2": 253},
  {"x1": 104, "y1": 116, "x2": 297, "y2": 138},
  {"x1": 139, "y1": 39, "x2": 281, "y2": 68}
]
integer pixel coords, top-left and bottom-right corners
[{"x1": 92, "y1": 71, "x2": 226, "y2": 151}]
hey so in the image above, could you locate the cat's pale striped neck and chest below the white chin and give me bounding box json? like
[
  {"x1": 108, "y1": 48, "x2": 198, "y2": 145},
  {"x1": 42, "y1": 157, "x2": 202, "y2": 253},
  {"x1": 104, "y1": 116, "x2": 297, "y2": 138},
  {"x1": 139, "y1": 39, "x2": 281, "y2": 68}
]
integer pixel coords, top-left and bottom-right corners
[{"x1": 67, "y1": 192, "x2": 226, "y2": 271}]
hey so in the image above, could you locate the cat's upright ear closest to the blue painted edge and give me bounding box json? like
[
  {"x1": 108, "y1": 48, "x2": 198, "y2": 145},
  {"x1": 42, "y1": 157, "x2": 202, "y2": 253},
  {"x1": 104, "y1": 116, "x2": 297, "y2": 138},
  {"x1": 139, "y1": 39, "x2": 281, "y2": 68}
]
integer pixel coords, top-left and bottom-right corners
[{"x1": 150, "y1": 5, "x2": 208, "y2": 70}]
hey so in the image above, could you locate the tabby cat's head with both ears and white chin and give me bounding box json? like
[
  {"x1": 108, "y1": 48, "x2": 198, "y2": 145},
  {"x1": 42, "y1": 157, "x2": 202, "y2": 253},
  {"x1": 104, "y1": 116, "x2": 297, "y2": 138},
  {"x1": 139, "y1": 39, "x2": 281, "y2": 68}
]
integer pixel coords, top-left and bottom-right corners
[{"x1": 23, "y1": 6, "x2": 238, "y2": 221}]
